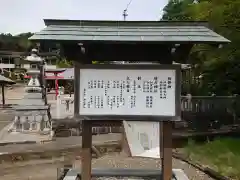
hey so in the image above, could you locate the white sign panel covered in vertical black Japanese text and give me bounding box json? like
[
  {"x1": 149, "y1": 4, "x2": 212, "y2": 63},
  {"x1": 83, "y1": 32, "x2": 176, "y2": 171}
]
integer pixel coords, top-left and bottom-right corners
[{"x1": 79, "y1": 69, "x2": 176, "y2": 116}]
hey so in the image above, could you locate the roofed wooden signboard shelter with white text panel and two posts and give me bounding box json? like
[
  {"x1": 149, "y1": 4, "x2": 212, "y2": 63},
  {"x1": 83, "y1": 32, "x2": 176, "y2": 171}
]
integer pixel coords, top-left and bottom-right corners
[{"x1": 30, "y1": 19, "x2": 229, "y2": 180}]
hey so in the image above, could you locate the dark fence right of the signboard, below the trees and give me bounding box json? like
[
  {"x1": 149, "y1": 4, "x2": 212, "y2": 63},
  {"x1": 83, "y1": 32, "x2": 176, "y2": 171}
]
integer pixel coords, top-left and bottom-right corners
[{"x1": 181, "y1": 96, "x2": 240, "y2": 131}]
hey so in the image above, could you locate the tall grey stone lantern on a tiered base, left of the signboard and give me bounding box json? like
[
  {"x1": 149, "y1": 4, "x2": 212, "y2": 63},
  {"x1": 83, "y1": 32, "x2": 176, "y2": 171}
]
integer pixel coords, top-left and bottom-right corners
[{"x1": 10, "y1": 49, "x2": 51, "y2": 134}]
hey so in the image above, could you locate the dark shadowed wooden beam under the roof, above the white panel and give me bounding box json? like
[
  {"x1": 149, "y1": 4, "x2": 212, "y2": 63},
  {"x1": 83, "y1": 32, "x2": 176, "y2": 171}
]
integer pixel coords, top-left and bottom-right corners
[{"x1": 87, "y1": 44, "x2": 171, "y2": 64}]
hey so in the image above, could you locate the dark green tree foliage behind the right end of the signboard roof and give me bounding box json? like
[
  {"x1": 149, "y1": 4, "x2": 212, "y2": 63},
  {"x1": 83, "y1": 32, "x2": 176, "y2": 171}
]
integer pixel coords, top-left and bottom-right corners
[{"x1": 162, "y1": 0, "x2": 240, "y2": 95}]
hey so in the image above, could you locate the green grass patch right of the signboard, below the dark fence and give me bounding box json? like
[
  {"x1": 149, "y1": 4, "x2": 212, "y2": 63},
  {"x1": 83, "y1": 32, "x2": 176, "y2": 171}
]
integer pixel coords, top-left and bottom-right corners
[{"x1": 183, "y1": 138, "x2": 240, "y2": 180}]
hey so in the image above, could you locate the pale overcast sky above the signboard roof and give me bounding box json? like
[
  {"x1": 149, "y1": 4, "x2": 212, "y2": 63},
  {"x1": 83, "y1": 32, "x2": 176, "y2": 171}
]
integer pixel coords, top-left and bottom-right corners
[{"x1": 0, "y1": 0, "x2": 168, "y2": 35}]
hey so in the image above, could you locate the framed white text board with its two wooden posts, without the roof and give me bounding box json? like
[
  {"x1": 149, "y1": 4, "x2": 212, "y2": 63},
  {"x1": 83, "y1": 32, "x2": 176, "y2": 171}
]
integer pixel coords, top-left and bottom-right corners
[{"x1": 74, "y1": 63, "x2": 181, "y2": 180}]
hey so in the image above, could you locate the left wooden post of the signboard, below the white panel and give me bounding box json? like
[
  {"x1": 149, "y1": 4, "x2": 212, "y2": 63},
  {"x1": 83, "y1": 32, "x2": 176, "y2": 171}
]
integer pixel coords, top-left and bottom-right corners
[{"x1": 81, "y1": 120, "x2": 92, "y2": 180}]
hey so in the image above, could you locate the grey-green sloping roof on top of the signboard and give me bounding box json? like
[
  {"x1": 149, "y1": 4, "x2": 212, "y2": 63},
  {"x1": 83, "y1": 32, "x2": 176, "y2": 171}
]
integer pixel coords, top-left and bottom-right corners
[{"x1": 30, "y1": 20, "x2": 230, "y2": 43}]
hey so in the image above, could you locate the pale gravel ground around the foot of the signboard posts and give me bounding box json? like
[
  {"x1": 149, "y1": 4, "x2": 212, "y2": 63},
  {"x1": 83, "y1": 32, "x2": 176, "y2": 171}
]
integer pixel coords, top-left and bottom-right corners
[{"x1": 0, "y1": 153, "x2": 213, "y2": 180}]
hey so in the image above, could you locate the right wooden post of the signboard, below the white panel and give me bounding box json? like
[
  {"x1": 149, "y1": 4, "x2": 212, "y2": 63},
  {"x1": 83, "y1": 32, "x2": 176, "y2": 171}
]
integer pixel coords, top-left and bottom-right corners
[{"x1": 160, "y1": 121, "x2": 172, "y2": 180}]
